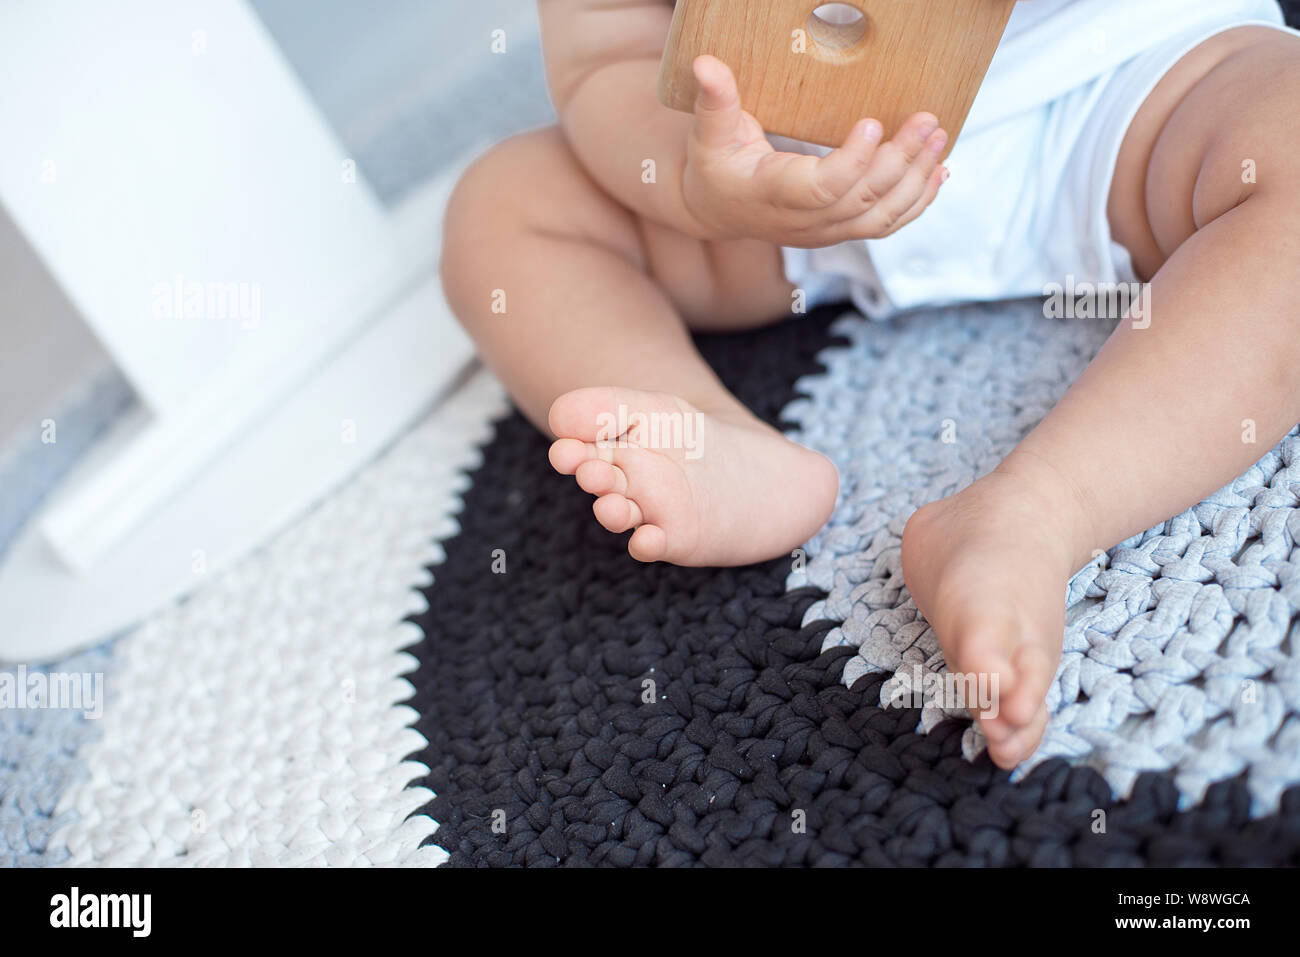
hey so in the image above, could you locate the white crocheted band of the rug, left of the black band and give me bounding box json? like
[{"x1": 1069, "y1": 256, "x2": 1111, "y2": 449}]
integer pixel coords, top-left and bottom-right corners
[{"x1": 51, "y1": 372, "x2": 506, "y2": 866}]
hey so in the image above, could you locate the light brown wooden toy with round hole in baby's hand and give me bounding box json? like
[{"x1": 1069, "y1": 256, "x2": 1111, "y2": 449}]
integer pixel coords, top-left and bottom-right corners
[{"x1": 659, "y1": 0, "x2": 1015, "y2": 156}]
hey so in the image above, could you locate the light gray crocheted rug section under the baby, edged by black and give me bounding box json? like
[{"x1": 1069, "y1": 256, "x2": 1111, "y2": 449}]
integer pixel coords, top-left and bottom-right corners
[{"x1": 785, "y1": 302, "x2": 1300, "y2": 815}]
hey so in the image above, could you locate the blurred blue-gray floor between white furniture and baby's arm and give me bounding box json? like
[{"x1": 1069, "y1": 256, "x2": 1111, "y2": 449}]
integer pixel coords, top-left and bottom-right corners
[{"x1": 252, "y1": 0, "x2": 553, "y2": 203}]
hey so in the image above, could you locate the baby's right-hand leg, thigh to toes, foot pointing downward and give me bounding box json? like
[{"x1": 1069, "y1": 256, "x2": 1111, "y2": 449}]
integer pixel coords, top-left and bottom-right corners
[{"x1": 902, "y1": 29, "x2": 1300, "y2": 767}]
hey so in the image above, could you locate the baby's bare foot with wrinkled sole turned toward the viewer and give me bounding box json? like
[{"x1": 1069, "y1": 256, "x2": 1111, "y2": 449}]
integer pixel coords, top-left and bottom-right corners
[{"x1": 550, "y1": 386, "x2": 839, "y2": 566}]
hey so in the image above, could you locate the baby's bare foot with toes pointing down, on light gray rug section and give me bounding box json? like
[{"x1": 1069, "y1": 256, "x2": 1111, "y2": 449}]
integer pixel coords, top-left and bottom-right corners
[{"x1": 902, "y1": 457, "x2": 1087, "y2": 768}]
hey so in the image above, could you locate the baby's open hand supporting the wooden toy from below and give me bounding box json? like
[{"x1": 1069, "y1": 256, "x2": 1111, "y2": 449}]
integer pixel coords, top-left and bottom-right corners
[{"x1": 683, "y1": 56, "x2": 948, "y2": 248}]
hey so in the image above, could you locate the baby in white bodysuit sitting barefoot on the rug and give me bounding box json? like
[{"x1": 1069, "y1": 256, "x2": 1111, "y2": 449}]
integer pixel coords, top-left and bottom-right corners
[{"x1": 442, "y1": 0, "x2": 1300, "y2": 767}]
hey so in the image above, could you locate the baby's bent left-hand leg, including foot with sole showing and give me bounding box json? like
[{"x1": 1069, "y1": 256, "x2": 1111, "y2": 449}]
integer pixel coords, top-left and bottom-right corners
[{"x1": 442, "y1": 129, "x2": 837, "y2": 564}]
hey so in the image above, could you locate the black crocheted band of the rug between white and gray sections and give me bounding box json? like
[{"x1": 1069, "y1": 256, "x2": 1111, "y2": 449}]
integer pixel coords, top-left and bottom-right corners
[{"x1": 408, "y1": 308, "x2": 1300, "y2": 866}]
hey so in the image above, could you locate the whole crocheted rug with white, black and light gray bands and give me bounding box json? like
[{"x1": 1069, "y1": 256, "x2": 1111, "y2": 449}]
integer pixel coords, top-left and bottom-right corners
[{"x1": 0, "y1": 303, "x2": 1300, "y2": 866}]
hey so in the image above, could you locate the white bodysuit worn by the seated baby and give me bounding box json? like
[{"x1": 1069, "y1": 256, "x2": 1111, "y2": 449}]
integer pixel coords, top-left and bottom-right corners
[{"x1": 774, "y1": 0, "x2": 1286, "y2": 317}]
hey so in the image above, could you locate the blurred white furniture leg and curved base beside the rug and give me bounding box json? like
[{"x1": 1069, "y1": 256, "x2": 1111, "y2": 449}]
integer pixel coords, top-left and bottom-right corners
[{"x1": 0, "y1": 0, "x2": 472, "y2": 661}]
